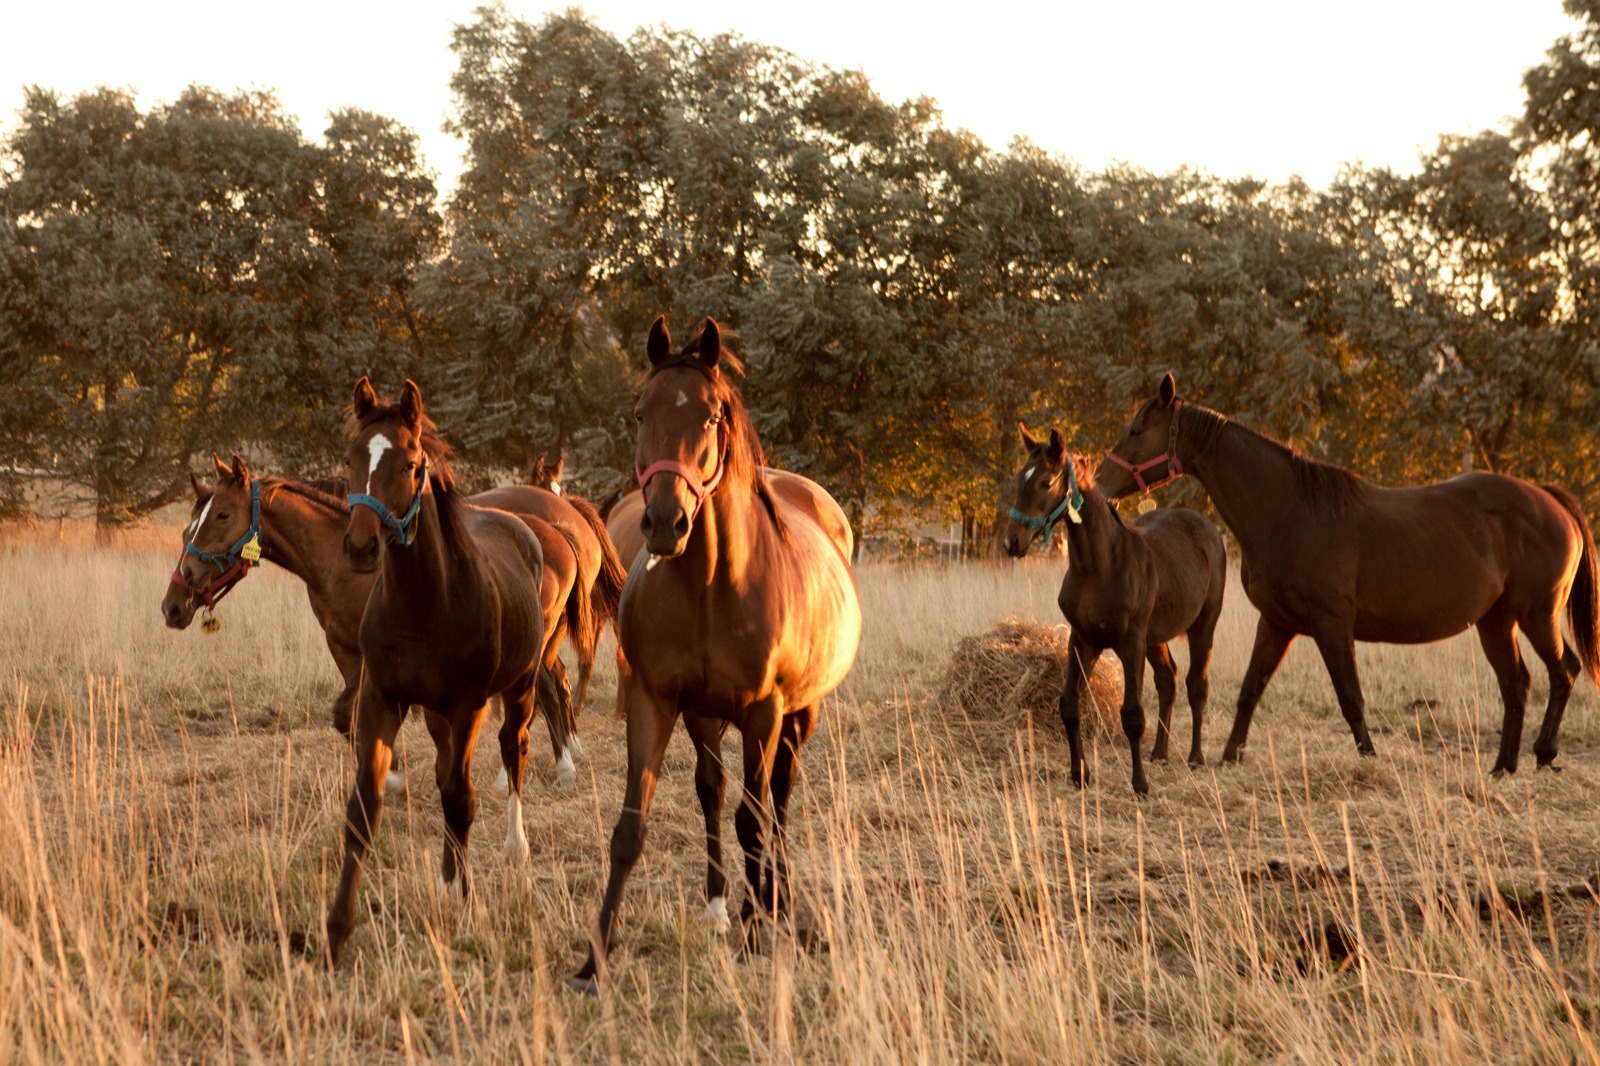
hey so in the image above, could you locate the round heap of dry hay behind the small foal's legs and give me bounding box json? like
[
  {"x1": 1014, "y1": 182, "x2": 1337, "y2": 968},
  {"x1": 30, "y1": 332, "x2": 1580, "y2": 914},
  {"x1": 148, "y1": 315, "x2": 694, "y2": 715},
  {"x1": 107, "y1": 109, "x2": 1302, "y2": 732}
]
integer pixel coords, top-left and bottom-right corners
[{"x1": 939, "y1": 618, "x2": 1122, "y2": 738}]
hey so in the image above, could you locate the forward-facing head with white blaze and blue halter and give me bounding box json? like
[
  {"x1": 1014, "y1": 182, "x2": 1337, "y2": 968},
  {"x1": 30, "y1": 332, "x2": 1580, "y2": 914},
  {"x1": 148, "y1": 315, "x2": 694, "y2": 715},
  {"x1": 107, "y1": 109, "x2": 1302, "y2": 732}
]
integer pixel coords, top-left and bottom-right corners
[{"x1": 344, "y1": 376, "x2": 432, "y2": 573}]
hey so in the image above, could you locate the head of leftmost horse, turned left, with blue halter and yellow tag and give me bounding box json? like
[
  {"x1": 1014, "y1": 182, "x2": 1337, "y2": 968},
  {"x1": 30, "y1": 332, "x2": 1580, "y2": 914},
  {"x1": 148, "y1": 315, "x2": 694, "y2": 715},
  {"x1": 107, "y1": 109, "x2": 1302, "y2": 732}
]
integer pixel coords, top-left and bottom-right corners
[{"x1": 162, "y1": 455, "x2": 261, "y2": 629}]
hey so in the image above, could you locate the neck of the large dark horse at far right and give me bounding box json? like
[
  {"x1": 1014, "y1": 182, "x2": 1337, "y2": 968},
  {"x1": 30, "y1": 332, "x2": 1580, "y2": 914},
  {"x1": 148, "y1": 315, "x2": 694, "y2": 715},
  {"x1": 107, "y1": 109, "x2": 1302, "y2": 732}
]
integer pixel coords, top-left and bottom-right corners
[{"x1": 1181, "y1": 424, "x2": 1299, "y2": 555}]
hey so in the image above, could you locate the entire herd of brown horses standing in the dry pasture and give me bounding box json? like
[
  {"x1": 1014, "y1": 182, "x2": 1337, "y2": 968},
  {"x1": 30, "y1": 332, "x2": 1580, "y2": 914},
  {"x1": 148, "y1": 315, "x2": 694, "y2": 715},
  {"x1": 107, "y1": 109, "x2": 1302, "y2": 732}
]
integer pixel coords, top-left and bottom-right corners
[{"x1": 162, "y1": 319, "x2": 1600, "y2": 992}]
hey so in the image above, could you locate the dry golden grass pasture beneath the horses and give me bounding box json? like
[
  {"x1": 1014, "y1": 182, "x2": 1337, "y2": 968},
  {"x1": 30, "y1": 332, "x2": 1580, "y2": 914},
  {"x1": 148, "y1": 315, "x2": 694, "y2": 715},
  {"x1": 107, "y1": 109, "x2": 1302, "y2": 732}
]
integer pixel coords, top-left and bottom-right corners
[{"x1": 0, "y1": 530, "x2": 1600, "y2": 1063}]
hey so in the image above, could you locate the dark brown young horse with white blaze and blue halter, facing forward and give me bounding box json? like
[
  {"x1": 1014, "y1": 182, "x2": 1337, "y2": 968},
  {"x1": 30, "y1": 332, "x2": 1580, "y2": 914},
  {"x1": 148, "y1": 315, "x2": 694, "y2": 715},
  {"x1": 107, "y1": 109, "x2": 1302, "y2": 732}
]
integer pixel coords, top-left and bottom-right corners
[{"x1": 328, "y1": 378, "x2": 546, "y2": 964}]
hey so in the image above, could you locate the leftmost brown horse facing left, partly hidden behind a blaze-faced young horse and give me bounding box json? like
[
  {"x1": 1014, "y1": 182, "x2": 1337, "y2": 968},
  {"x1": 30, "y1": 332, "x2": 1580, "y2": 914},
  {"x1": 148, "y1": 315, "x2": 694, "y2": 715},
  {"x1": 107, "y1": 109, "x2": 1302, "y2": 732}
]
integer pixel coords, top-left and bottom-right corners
[{"x1": 162, "y1": 456, "x2": 594, "y2": 781}]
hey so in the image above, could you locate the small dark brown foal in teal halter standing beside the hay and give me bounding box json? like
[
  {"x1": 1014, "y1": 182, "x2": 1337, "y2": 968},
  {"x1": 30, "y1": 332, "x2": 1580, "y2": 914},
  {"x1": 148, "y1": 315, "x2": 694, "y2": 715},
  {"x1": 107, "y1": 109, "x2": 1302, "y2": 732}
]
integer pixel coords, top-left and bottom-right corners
[{"x1": 1002, "y1": 424, "x2": 1227, "y2": 792}]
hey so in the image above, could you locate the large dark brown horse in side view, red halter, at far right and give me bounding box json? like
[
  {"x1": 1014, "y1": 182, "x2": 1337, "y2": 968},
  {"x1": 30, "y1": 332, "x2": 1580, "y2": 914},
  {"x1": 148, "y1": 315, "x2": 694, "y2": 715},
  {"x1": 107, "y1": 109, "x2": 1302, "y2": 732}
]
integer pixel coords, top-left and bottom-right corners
[{"x1": 1096, "y1": 375, "x2": 1600, "y2": 773}]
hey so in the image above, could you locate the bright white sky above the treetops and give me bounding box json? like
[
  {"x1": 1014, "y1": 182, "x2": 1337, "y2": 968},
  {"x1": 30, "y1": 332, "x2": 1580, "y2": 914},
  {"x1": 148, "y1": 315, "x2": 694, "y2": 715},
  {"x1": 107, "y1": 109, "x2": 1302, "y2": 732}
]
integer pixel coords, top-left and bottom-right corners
[{"x1": 0, "y1": 0, "x2": 1574, "y2": 186}]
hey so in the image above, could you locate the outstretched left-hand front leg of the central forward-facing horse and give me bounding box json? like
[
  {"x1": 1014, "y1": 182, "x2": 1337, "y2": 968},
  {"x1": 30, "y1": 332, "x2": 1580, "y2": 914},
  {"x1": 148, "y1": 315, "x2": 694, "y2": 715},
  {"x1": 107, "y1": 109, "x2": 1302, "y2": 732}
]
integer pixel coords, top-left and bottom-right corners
[{"x1": 573, "y1": 683, "x2": 678, "y2": 996}]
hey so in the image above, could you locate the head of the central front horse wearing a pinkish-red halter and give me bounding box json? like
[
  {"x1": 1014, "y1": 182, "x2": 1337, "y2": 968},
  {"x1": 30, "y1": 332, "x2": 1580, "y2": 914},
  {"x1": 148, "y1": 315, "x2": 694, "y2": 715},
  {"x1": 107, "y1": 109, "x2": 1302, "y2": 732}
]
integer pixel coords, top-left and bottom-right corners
[{"x1": 634, "y1": 319, "x2": 736, "y2": 557}]
